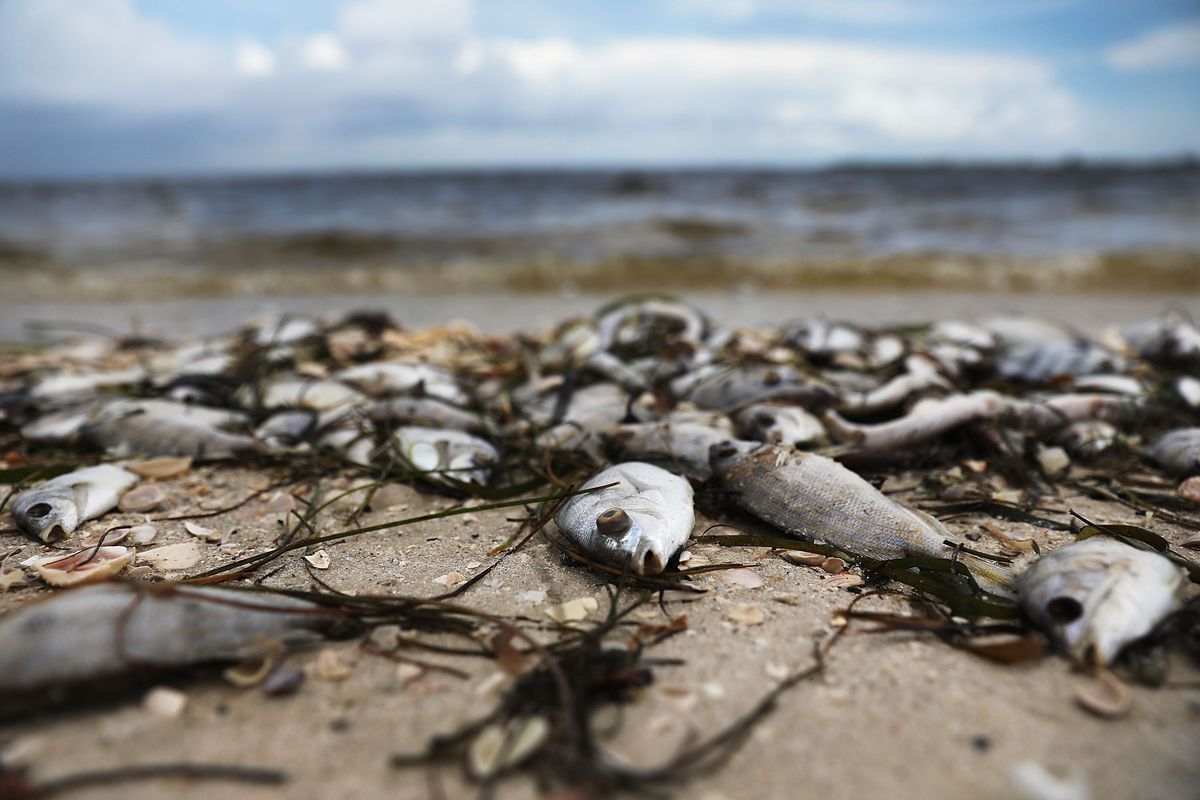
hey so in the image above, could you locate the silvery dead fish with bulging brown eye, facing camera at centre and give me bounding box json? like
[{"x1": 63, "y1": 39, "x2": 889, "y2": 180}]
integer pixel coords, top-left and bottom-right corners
[{"x1": 554, "y1": 461, "x2": 696, "y2": 575}]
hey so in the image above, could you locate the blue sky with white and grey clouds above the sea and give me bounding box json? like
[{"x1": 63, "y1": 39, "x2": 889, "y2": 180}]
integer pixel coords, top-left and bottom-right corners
[{"x1": 0, "y1": 0, "x2": 1200, "y2": 179}]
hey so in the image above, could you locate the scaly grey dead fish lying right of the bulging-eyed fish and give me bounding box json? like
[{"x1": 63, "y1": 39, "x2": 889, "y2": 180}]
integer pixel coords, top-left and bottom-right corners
[{"x1": 712, "y1": 444, "x2": 1012, "y2": 594}]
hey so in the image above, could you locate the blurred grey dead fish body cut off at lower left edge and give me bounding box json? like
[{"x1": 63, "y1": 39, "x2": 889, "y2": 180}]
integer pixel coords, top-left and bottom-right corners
[{"x1": 0, "y1": 583, "x2": 332, "y2": 702}]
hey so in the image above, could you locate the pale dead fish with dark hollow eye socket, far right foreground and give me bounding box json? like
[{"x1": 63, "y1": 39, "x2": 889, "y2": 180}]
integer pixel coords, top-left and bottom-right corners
[{"x1": 1016, "y1": 536, "x2": 1186, "y2": 666}]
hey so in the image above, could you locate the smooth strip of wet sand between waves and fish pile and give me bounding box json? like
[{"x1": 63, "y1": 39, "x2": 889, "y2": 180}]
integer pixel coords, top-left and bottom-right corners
[{"x1": 0, "y1": 290, "x2": 1200, "y2": 342}]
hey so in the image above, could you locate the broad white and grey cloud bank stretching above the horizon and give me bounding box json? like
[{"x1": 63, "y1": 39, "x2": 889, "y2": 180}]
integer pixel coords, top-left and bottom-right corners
[{"x1": 0, "y1": 0, "x2": 1099, "y2": 174}]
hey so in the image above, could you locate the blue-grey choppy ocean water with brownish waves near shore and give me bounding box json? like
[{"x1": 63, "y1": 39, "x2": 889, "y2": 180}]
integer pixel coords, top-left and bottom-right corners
[{"x1": 0, "y1": 163, "x2": 1200, "y2": 294}]
